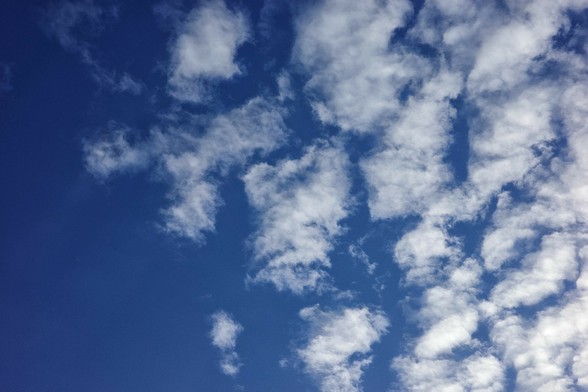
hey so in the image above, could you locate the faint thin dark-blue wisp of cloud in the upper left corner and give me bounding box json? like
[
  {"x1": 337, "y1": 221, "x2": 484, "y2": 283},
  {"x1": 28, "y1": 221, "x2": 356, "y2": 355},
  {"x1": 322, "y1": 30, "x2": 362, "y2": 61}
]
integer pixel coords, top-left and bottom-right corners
[{"x1": 41, "y1": 0, "x2": 143, "y2": 95}]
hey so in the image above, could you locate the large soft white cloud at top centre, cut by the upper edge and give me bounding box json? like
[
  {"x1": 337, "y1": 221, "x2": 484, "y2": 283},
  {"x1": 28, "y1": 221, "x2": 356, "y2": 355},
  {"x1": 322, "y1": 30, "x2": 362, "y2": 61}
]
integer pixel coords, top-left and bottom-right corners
[{"x1": 293, "y1": 0, "x2": 429, "y2": 131}]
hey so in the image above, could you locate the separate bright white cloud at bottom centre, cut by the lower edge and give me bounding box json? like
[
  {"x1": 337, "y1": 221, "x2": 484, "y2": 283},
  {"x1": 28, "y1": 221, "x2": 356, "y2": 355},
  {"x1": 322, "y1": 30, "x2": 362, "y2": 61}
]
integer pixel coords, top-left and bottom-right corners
[{"x1": 298, "y1": 305, "x2": 389, "y2": 392}]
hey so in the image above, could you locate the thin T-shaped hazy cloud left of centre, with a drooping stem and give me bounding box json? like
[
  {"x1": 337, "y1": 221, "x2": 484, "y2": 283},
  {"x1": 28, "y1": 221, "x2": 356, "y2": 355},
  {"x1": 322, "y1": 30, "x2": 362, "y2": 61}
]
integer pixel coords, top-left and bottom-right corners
[{"x1": 84, "y1": 98, "x2": 287, "y2": 243}]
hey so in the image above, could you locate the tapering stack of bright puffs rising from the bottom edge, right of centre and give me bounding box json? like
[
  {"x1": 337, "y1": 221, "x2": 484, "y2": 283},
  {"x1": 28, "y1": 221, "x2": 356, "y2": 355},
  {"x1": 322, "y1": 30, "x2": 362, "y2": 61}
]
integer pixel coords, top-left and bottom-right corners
[{"x1": 392, "y1": 259, "x2": 505, "y2": 391}]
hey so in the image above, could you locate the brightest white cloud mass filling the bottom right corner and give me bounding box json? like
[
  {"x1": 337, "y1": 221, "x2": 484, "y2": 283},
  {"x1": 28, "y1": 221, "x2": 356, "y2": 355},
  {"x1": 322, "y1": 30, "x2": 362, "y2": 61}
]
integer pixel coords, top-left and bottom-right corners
[{"x1": 492, "y1": 264, "x2": 588, "y2": 392}]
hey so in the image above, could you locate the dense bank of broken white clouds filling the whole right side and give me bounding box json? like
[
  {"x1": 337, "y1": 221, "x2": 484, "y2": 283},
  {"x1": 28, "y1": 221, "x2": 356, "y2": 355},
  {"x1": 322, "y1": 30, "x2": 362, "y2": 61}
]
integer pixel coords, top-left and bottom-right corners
[{"x1": 294, "y1": 0, "x2": 588, "y2": 390}]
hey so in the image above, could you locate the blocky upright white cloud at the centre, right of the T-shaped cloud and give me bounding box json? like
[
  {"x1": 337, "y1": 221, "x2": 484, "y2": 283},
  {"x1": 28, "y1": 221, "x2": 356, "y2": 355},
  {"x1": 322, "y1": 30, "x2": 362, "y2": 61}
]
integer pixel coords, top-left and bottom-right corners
[{"x1": 243, "y1": 143, "x2": 350, "y2": 294}]
